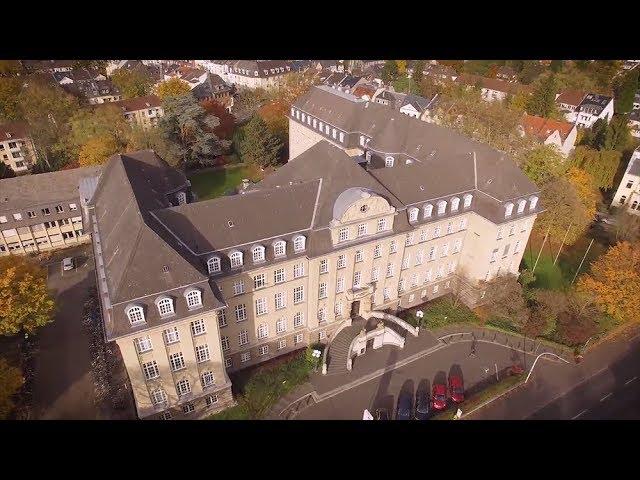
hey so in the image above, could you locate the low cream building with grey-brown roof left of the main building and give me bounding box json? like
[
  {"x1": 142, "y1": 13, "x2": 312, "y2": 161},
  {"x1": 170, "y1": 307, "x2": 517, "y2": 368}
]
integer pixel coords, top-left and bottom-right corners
[{"x1": 0, "y1": 167, "x2": 101, "y2": 255}]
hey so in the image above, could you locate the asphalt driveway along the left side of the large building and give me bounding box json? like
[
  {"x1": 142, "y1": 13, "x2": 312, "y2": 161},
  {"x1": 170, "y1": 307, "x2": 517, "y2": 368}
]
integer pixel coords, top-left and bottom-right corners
[{"x1": 33, "y1": 245, "x2": 98, "y2": 420}]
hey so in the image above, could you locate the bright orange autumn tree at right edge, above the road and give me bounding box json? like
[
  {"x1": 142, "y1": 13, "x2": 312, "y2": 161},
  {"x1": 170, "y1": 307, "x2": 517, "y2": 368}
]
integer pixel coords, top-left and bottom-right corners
[{"x1": 578, "y1": 241, "x2": 640, "y2": 322}]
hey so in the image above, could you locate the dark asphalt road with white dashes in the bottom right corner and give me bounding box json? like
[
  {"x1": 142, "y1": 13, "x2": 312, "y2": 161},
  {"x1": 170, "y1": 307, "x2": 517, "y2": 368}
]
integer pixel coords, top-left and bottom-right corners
[{"x1": 527, "y1": 339, "x2": 640, "y2": 420}]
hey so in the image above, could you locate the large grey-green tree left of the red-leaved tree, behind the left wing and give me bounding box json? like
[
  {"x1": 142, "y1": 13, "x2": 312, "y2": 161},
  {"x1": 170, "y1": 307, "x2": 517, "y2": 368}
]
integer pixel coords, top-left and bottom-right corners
[{"x1": 159, "y1": 94, "x2": 228, "y2": 167}]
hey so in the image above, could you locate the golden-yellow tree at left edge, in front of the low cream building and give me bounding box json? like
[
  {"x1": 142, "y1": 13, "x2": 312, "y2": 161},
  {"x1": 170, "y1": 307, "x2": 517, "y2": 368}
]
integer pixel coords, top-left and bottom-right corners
[{"x1": 0, "y1": 255, "x2": 55, "y2": 335}]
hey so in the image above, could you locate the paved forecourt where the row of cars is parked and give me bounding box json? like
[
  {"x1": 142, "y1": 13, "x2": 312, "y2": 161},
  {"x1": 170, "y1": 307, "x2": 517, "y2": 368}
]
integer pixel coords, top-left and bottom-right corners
[{"x1": 296, "y1": 342, "x2": 534, "y2": 420}]
